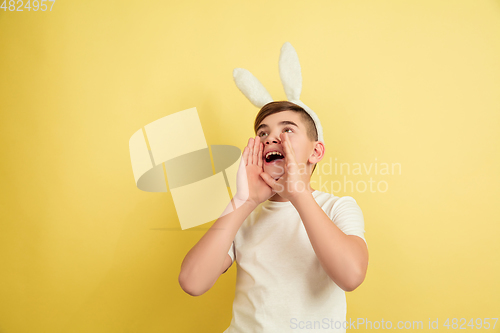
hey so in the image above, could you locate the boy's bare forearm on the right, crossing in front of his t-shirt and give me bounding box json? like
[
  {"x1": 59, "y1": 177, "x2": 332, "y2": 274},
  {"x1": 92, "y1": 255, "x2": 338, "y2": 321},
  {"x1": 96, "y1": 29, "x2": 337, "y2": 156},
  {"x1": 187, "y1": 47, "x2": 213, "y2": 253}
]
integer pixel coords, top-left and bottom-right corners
[{"x1": 292, "y1": 193, "x2": 368, "y2": 291}]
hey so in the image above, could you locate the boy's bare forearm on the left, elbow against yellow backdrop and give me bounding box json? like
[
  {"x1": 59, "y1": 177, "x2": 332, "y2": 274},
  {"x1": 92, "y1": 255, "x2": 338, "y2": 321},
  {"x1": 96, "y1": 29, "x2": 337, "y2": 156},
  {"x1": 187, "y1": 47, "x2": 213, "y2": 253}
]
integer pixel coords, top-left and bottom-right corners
[{"x1": 179, "y1": 196, "x2": 256, "y2": 296}]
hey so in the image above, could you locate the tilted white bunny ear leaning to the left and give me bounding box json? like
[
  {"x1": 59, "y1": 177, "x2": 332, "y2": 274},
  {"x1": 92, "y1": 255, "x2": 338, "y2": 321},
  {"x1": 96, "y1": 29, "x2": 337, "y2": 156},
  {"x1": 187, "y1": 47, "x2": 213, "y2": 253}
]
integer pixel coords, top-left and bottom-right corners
[{"x1": 233, "y1": 68, "x2": 273, "y2": 108}]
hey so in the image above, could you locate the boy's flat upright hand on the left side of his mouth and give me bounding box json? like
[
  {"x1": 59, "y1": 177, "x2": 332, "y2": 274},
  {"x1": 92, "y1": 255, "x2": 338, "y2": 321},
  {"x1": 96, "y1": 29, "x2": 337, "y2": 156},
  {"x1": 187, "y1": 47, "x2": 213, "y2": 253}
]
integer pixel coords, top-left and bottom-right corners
[{"x1": 234, "y1": 136, "x2": 275, "y2": 206}]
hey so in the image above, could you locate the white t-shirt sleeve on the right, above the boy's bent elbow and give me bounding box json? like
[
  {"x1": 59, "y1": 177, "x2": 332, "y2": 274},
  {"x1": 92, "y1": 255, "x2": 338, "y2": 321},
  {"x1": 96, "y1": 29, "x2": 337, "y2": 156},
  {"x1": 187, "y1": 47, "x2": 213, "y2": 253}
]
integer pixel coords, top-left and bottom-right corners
[{"x1": 329, "y1": 196, "x2": 368, "y2": 246}]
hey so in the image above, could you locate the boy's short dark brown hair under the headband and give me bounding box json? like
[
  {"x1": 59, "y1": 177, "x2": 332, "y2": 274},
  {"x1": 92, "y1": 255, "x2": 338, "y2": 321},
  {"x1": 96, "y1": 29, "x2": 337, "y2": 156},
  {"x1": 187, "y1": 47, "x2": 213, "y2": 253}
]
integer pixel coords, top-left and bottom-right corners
[{"x1": 253, "y1": 101, "x2": 318, "y2": 174}]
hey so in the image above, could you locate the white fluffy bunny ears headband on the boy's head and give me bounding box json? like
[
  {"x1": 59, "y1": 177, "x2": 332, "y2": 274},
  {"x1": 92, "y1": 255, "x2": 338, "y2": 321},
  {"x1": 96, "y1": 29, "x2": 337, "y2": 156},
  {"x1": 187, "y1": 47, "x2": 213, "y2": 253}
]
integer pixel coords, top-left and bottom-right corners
[{"x1": 233, "y1": 42, "x2": 323, "y2": 141}]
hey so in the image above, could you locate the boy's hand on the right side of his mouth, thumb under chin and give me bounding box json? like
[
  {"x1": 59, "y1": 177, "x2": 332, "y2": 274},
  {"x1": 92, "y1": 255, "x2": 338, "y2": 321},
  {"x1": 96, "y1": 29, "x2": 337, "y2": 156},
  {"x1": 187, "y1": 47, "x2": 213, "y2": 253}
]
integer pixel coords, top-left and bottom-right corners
[{"x1": 260, "y1": 132, "x2": 310, "y2": 201}]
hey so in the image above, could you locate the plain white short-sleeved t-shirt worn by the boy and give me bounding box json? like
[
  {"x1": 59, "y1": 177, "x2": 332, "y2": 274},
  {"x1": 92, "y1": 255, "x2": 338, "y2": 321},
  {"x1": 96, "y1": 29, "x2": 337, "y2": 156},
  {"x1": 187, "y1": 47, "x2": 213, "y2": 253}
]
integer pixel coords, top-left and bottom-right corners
[{"x1": 224, "y1": 190, "x2": 366, "y2": 333}]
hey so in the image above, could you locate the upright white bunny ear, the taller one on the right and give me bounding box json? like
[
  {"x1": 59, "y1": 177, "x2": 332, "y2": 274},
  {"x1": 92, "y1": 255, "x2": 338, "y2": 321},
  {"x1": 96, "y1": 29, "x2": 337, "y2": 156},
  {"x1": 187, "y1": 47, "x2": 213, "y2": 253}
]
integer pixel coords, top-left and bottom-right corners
[{"x1": 279, "y1": 42, "x2": 302, "y2": 101}]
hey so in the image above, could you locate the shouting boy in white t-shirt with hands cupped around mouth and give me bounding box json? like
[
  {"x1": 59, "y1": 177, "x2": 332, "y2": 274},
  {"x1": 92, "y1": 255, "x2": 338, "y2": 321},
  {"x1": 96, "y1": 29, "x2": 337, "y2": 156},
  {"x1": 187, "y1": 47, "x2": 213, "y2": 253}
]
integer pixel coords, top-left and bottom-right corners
[{"x1": 179, "y1": 101, "x2": 368, "y2": 333}]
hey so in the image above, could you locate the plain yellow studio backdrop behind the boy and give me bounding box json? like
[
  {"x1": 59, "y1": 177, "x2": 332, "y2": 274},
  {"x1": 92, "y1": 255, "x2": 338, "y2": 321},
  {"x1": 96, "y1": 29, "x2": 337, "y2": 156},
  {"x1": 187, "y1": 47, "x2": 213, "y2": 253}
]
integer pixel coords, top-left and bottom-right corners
[{"x1": 0, "y1": 0, "x2": 500, "y2": 333}]
